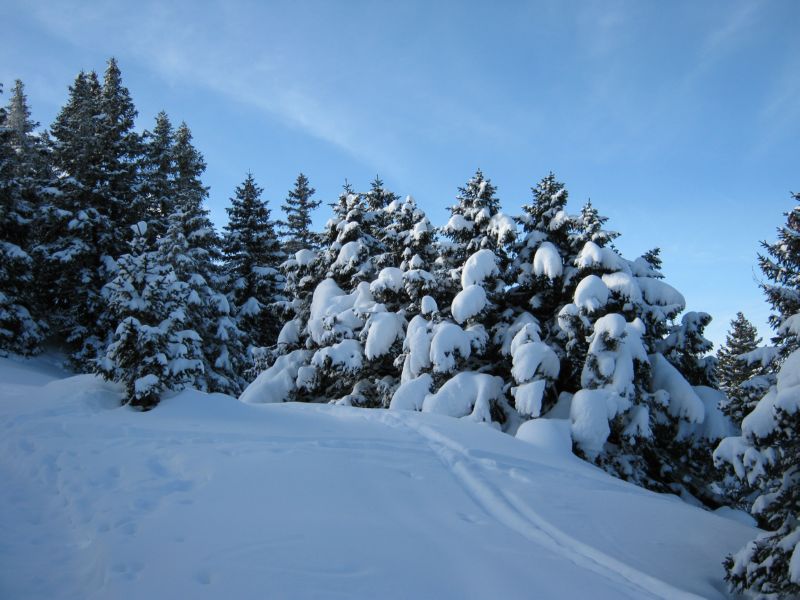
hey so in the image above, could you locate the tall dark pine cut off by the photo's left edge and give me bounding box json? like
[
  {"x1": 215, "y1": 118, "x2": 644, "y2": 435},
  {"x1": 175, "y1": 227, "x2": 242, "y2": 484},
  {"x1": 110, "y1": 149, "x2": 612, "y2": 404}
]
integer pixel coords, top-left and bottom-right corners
[{"x1": 0, "y1": 81, "x2": 43, "y2": 354}]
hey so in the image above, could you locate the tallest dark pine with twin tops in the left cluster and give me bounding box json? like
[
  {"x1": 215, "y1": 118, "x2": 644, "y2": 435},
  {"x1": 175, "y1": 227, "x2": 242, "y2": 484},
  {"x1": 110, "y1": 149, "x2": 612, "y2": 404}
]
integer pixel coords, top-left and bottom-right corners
[{"x1": 37, "y1": 59, "x2": 142, "y2": 368}]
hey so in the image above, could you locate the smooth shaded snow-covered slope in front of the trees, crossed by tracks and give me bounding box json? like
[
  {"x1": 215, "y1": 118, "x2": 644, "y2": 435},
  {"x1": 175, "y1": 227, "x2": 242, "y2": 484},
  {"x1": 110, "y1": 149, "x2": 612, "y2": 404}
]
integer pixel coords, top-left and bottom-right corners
[{"x1": 0, "y1": 358, "x2": 756, "y2": 600}]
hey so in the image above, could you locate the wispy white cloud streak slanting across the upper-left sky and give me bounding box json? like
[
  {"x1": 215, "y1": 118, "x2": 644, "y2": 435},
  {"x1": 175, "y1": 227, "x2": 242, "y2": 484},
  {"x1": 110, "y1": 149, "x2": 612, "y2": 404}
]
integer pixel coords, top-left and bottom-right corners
[{"x1": 17, "y1": 3, "x2": 418, "y2": 176}]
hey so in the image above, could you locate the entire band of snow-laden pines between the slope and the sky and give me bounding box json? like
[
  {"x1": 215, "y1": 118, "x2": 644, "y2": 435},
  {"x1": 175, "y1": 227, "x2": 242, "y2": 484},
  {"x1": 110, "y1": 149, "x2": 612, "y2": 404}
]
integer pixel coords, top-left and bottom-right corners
[{"x1": 0, "y1": 59, "x2": 800, "y2": 595}]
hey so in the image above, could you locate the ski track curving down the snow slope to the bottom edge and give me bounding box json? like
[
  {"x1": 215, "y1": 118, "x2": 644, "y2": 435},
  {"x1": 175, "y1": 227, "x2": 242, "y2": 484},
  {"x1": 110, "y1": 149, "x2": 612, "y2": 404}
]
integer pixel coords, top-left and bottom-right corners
[{"x1": 384, "y1": 412, "x2": 703, "y2": 600}]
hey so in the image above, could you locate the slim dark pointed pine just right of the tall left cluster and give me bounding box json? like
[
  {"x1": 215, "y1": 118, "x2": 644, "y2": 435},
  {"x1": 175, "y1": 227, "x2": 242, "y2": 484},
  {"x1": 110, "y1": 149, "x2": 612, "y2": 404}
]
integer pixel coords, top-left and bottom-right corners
[{"x1": 223, "y1": 173, "x2": 283, "y2": 347}]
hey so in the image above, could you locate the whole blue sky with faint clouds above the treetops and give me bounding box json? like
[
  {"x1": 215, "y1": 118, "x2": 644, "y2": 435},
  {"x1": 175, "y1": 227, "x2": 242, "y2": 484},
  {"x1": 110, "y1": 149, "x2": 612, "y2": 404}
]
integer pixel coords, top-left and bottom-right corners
[{"x1": 0, "y1": 0, "x2": 800, "y2": 342}]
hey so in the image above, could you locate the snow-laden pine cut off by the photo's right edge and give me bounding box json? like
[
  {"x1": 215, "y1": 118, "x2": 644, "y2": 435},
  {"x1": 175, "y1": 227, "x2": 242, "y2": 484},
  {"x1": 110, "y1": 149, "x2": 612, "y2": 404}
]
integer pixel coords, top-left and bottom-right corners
[{"x1": 714, "y1": 194, "x2": 800, "y2": 598}]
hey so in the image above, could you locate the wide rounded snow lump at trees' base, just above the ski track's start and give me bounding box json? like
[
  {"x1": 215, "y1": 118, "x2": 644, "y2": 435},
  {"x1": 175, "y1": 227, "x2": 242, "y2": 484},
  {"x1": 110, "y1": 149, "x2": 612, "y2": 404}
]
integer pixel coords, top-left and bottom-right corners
[{"x1": 422, "y1": 371, "x2": 503, "y2": 423}]
